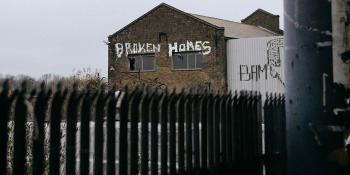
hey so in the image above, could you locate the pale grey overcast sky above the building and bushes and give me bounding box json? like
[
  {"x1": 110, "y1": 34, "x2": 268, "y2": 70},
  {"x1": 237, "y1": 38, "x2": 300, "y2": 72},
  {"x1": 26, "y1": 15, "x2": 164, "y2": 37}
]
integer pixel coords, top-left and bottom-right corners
[{"x1": 0, "y1": 0, "x2": 283, "y2": 78}]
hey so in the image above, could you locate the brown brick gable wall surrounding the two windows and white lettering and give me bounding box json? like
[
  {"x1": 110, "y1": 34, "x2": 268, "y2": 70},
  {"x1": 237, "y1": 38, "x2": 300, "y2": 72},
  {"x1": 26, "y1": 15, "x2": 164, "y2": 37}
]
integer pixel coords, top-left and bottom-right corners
[{"x1": 108, "y1": 6, "x2": 226, "y2": 90}]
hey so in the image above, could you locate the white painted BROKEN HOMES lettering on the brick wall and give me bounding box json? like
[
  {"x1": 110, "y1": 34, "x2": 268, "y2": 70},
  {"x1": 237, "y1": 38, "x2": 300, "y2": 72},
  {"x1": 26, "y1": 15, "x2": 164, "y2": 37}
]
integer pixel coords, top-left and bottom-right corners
[{"x1": 115, "y1": 41, "x2": 211, "y2": 58}]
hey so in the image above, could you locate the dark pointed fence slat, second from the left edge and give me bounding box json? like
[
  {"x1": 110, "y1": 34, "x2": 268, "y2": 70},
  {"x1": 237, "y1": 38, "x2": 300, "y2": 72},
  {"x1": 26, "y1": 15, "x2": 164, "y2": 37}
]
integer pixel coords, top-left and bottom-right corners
[{"x1": 13, "y1": 83, "x2": 28, "y2": 175}]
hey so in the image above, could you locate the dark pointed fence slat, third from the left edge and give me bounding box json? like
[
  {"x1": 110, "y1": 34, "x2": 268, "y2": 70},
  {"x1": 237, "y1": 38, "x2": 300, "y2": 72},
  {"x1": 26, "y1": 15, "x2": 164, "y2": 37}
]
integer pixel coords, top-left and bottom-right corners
[{"x1": 32, "y1": 83, "x2": 51, "y2": 175}]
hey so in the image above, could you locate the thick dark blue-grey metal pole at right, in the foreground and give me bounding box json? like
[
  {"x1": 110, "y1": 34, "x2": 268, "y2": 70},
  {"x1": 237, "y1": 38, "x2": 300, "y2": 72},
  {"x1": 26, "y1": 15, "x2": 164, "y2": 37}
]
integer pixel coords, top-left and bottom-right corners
[{"x1": 284, "y1": 0, "x2": 337, "y2": 175}]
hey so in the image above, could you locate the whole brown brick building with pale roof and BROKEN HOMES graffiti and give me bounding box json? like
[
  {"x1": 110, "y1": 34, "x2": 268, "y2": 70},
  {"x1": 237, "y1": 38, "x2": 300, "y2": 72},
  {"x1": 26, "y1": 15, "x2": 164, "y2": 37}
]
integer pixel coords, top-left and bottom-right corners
[{"x1": 108, "y1": 3, "x2": 282, "y2": 90}]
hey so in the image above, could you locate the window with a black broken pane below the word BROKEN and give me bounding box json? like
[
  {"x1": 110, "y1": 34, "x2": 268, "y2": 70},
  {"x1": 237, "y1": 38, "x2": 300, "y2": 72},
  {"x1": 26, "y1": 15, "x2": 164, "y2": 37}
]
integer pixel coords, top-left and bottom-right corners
[{"x1": 128, "y1": 54, "x2": 155, "y2": 72}]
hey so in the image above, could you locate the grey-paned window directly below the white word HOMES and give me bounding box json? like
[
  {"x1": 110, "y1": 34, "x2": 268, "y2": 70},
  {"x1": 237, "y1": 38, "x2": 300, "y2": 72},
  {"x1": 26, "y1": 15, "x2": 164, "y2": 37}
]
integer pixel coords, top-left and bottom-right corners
[{"x1": 172, "y1": 52, "x2": 203, "y2": 70}]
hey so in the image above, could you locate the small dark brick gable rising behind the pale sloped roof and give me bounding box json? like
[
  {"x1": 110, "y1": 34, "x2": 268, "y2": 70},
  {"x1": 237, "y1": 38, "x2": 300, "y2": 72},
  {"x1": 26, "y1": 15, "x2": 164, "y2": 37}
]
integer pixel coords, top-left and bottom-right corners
[{"x1": 242, "y1": 11, "x2": 282, "y2": 34}]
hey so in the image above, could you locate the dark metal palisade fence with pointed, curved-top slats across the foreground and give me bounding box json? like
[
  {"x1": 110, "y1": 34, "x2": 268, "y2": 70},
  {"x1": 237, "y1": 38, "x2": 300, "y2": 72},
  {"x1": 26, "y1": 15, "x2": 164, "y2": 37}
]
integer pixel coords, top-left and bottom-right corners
[{"x1": 0, "y1": 82, "x2": 285, "y2": 175}]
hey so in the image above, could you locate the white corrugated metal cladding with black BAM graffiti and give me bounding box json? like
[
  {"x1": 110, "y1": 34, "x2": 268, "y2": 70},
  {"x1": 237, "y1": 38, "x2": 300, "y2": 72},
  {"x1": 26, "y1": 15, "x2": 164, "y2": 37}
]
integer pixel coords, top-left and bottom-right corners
[{"x1": 227, "y1": 36, "x2": 285, "y2": 96}]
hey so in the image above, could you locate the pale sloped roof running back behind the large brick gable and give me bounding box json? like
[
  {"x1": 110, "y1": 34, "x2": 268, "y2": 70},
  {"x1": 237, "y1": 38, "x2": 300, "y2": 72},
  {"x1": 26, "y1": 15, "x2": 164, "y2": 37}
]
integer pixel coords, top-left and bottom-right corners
[{"x1": 192, "y1": 14, "x2": 278, "y2": 38}]
